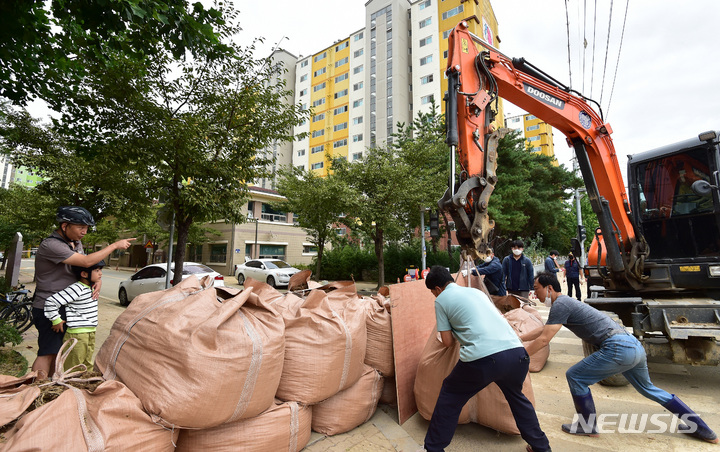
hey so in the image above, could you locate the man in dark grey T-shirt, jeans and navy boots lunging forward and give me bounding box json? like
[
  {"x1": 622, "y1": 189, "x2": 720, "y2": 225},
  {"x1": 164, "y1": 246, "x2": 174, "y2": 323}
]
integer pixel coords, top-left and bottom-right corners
[{"x1": 520, "y1": 272, "x2": 718, "y2": 443}]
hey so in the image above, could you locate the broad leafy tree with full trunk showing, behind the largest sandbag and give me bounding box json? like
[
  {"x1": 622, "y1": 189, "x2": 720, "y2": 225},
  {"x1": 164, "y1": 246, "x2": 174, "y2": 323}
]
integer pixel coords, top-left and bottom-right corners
[{"x1": 5, "y1": 20, "x2": 307, "y2": 282}]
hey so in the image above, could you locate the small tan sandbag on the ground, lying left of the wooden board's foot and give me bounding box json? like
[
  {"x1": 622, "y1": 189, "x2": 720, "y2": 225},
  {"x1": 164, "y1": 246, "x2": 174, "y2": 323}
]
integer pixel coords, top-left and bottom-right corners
[{"x1": 312, "y1": 366, "x2": 383, "y2": 435}]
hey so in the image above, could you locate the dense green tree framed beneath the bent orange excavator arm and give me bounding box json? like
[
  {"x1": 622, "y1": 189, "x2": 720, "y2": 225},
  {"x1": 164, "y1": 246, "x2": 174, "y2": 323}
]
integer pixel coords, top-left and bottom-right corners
[{"x1": 488, "y1": 131, "x2": 582, "y2": 249}]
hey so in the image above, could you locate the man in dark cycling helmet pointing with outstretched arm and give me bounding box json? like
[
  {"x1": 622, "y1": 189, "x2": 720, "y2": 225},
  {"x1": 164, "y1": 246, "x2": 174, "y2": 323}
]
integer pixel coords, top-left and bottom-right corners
[{"x1": 32, "y1": 206, "x2": 135, "y2": 379}]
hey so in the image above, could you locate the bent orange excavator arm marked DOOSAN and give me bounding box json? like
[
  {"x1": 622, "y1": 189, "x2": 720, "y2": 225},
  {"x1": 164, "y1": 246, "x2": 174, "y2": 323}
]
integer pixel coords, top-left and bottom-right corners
[{"x1": 439, "y1": 21, "x2": 646, "y2": 285}]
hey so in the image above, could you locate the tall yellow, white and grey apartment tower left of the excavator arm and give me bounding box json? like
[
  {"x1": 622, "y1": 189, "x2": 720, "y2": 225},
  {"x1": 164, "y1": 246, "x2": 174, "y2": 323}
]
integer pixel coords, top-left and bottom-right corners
[{"x1": 292, "y1": 0, "x2": 502, "y2": 175}]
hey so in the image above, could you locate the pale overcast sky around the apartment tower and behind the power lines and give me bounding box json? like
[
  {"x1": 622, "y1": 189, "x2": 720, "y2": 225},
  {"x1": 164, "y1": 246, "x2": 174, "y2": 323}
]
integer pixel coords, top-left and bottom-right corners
[{"x1": 236, "y1": 0, "x2": 720, "y2": 171}]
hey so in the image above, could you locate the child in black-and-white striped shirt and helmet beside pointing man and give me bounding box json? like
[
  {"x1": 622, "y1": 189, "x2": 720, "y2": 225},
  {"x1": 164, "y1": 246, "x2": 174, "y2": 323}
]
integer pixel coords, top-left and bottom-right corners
[{"x1": 45, "y1": 261, "x2": 105, "y2": 370}]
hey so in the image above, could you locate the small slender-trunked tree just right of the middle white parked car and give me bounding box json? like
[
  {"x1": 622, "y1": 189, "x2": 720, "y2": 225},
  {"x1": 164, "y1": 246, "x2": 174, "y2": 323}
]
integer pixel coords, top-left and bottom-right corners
[{"x1": 277, "y1": 166, "x2": 349, "y2": 279}]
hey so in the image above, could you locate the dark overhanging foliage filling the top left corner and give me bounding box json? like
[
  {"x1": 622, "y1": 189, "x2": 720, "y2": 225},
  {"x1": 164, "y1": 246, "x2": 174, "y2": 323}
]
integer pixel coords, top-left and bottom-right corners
[{"x1": 0, "y1": 0, "x2": 232, "y2": 106}]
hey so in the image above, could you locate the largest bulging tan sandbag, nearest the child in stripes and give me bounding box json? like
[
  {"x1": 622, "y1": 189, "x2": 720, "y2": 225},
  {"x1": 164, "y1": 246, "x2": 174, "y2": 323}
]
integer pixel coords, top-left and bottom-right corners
[{"x1": 95, "y1": 276, "x2": 284, "y2": 428}]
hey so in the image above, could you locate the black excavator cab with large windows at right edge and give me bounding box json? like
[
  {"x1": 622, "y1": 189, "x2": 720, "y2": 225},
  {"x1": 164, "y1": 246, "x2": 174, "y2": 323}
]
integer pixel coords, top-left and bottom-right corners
[{"x1": 628, "y1": 133, "x2": 720, "y2": 286}]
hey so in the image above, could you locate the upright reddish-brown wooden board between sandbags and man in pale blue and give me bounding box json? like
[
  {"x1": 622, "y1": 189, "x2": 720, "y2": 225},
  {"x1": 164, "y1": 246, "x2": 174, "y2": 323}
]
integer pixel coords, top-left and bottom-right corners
[{"x1": 389, "y1": 280, "x2": 435, "y2": 425}]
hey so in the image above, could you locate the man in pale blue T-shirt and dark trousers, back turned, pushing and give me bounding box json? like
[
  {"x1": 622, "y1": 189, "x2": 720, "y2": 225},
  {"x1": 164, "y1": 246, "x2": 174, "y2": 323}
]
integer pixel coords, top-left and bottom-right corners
[{"x1": 425, "y1": 265, "x2": 550, "y2": 452}]
